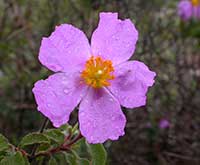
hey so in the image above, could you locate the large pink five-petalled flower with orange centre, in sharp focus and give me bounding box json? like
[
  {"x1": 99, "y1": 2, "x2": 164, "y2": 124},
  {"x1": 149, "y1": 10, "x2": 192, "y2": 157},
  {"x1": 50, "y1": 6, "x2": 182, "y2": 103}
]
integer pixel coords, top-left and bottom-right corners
[{"x1": 33, "y1": 13, "x2": 156, "y2": 143}]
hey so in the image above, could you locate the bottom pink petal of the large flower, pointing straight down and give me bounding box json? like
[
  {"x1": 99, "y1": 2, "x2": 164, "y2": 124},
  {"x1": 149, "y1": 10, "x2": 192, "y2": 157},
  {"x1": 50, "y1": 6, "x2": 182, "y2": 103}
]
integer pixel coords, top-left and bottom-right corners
[{"x1": 79, "y1": 88, "x2": 126, "y2": 143}]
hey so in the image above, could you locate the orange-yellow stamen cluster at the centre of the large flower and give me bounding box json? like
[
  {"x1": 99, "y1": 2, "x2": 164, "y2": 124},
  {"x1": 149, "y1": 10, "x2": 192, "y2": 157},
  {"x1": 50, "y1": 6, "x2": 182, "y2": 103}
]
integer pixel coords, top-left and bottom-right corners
[{"x1": 81, "y1": 56, "x2": 115, "y2": 88}]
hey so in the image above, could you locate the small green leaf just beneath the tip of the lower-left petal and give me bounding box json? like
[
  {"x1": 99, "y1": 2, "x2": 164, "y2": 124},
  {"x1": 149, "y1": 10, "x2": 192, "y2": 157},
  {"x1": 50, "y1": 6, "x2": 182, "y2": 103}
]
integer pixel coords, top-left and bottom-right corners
[{"x1": 45, "y1": 129, "x2": 65, "y2": 144}]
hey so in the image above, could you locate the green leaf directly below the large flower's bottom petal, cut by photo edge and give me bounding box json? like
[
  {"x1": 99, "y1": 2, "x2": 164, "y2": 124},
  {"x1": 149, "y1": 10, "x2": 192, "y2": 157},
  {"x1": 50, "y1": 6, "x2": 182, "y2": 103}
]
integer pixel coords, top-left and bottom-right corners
[{"x1": 87, "y1": 144, "x2": 107, "y2": 165}]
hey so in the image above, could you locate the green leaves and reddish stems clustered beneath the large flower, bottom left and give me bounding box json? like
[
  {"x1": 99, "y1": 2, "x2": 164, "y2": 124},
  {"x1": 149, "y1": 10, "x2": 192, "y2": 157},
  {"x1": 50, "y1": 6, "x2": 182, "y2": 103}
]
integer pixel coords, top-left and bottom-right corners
[{"x1": 0, "y1": 124, "x2": 107, "y2": 165}]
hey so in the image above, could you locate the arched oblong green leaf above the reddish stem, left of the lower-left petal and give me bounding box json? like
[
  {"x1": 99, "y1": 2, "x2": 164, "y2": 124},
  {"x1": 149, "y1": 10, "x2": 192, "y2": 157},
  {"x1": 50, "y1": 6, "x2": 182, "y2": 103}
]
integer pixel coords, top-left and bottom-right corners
[{"x1": 19, "y1": 133, "x2": 50, "y2": 147}]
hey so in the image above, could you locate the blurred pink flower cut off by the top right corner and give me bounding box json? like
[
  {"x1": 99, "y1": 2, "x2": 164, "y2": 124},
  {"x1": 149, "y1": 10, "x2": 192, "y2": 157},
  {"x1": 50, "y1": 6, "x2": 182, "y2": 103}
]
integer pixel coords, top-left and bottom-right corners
[{"x1": 178, "y1": 0, "x2": 200, "y2": 21}]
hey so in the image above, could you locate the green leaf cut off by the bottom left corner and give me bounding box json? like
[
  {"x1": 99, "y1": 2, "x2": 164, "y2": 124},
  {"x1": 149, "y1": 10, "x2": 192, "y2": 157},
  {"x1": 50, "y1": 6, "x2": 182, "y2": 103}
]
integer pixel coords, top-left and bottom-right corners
[{"x1": 0, "y1": 152, "x2": 29, "y2": 165}]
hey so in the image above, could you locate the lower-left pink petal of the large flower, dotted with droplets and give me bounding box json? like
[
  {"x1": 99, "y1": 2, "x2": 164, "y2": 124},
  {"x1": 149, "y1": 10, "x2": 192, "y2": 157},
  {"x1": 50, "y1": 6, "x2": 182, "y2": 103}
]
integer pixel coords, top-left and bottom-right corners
[{"x1": 33, "y1": 73, "x2": 86, "y2": 127}]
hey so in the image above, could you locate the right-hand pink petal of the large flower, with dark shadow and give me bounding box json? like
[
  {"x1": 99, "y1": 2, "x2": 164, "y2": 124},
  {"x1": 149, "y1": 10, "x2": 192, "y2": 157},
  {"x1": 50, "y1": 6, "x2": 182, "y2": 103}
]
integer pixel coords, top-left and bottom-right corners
[{"x1": 108, "y1": 61, "x2": 156, "y2": 108}]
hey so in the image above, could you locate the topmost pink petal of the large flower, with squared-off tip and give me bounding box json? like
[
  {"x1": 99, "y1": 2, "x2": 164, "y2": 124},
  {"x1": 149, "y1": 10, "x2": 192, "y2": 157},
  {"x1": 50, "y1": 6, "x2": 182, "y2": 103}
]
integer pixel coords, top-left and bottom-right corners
[{"x1": 91, "y1": 13, "x2": 138, "y2": 65}]
